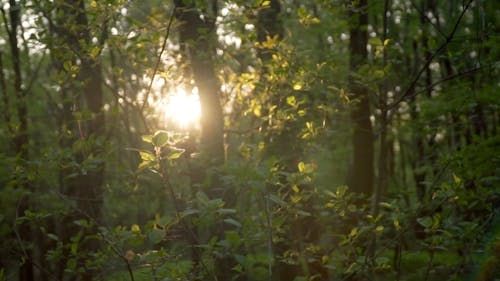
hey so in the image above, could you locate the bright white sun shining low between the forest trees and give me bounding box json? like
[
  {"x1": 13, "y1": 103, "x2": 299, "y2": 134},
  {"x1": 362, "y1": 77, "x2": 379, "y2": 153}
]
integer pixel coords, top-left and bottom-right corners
[{"x1": 164, "y1": 88, "x2": 201, "y2": 129}]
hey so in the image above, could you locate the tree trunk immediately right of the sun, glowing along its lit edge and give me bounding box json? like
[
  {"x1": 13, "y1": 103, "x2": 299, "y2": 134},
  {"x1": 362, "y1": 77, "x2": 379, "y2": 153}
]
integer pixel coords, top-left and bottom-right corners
[{"x1": 174, "y1": 0, "x2": 230, "y2": 280}]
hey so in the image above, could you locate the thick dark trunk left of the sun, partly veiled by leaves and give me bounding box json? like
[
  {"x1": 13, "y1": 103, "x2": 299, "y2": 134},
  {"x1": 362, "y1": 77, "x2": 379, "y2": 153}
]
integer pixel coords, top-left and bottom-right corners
[{"x1": 50, "y1": 0, "x2": 106, "y2": 280}]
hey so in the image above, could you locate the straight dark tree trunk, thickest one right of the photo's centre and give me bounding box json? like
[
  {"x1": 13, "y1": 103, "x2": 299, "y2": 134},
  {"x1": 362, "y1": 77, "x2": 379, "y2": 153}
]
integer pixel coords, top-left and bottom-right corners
[{"x1": 348, "y1": 0, "x2": 374, "y2": 195}]
